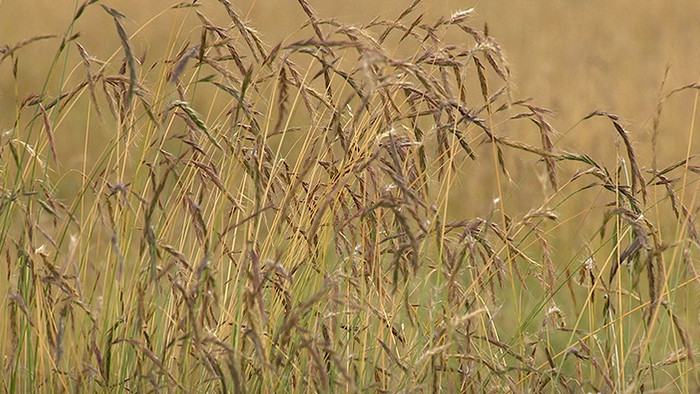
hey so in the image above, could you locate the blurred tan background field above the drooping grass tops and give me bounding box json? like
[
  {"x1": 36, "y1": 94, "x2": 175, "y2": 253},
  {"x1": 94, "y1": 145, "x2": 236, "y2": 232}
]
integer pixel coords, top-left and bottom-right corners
[{"x1": 0, "y1": 0, "x2": 700, "y2": 213}]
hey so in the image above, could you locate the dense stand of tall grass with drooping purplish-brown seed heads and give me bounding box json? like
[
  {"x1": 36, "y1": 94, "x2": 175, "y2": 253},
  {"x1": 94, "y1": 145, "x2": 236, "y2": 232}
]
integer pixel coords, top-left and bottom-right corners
[{"x1": 0, "y1": 0, "x2": 700, "y2": 392}]
